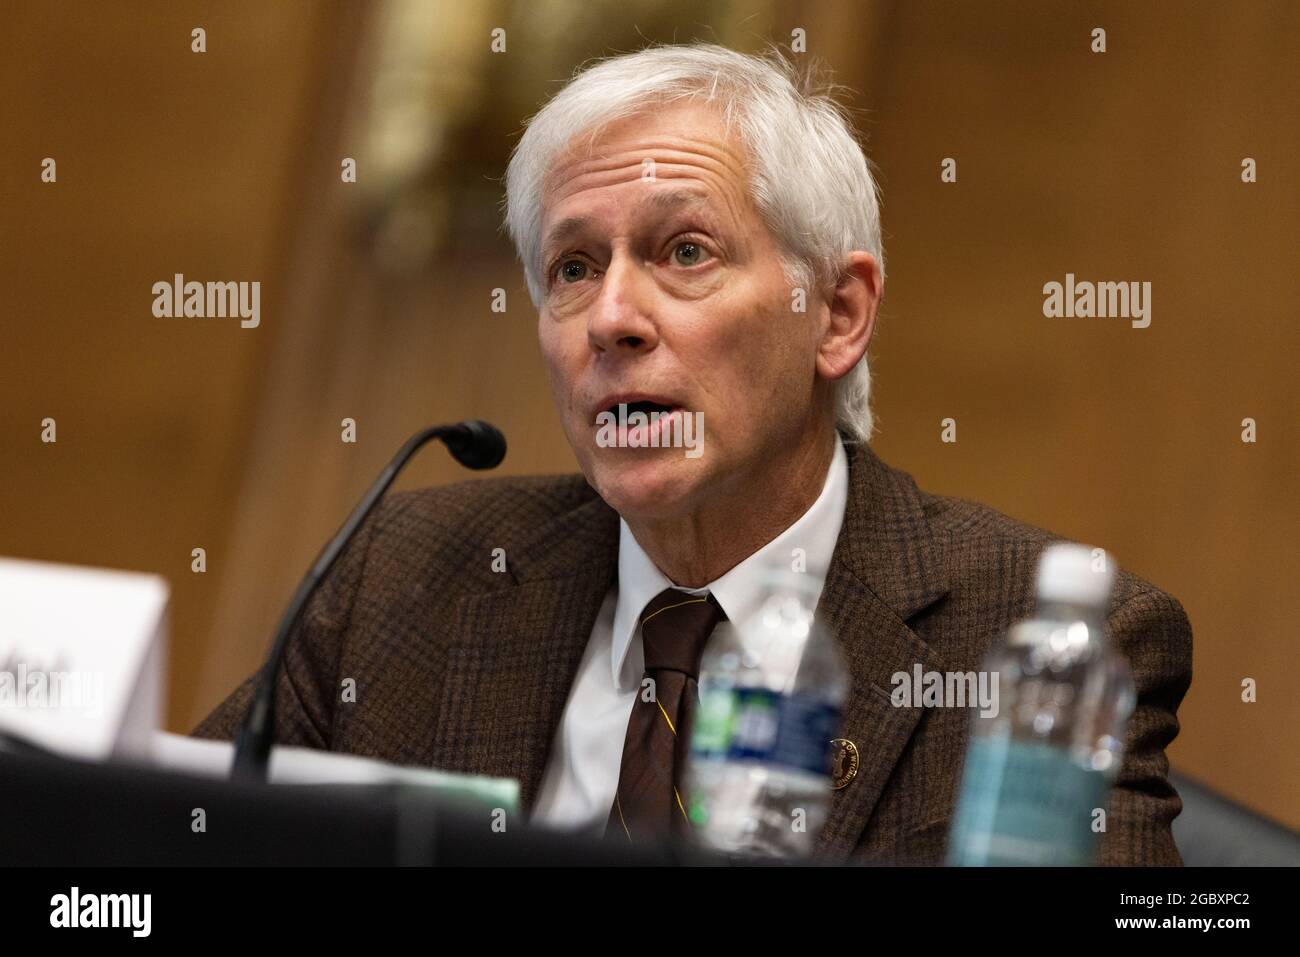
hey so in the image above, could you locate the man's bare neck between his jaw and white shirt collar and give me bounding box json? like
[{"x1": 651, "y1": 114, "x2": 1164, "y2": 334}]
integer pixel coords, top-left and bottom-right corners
[{"x1": 627, "y1": 429, "x2": 839, "y2": 588}]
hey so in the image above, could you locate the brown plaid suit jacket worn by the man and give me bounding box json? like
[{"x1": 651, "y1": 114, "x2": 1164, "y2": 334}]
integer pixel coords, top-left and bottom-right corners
[{"x1": 194, "y1": 443, "x2": 1192, "y2": 865}]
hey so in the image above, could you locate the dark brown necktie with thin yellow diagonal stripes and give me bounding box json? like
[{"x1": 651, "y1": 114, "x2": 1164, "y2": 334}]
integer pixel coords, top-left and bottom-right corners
[{"x1": 605, "y1": 588, "x2": 727, "y2": 840}]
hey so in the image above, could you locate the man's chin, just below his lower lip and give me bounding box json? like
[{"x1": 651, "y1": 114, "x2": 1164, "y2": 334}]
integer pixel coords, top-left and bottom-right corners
[{"x1": 588, "y1": 449, "x2": 703, "y2": 520}]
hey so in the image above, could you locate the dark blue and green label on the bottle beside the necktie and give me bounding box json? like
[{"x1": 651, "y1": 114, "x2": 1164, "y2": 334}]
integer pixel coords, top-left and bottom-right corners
[{"x1": 690, "y1": 688, "x2": 840, "y2": 776}]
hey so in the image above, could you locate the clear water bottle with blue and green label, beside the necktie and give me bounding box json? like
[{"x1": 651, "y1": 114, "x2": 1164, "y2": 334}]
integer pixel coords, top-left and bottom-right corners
[{"x1": 686, "y1": 571, "x2": 849, "y2": 857}]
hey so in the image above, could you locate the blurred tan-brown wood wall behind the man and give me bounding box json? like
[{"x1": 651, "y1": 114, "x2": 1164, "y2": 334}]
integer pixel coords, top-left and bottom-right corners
[{"x1": 0, "y1": 0, "x2": 1300, "y2": 827}]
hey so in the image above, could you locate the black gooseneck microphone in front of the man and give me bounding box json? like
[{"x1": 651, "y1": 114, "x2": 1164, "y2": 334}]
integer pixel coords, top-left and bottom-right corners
[{"x1": 230, "y1": 420, "x2": 506, "y2": 781}]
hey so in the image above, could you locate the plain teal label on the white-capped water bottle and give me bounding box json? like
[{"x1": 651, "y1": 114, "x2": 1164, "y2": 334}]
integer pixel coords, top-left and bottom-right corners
[{"x1": 948, "y1": 736, "x2": 1109, "y2": 867}]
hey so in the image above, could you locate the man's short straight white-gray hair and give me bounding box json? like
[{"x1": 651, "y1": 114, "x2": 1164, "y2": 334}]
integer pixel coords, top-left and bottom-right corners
[{"x1": 506, "y1": 44, "x2": 884, "y2": 442}]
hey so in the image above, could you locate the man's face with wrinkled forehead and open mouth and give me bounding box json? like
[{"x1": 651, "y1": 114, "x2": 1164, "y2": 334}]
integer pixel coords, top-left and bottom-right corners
[{"x1": 538, "y1": 104, "x2": 827, "y2": 519}]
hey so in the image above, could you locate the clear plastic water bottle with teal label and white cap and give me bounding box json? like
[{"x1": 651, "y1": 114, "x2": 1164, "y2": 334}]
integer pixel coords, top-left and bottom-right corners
[{"x1": 948, "y1": 545, "x2": 1135, "y2": 866}]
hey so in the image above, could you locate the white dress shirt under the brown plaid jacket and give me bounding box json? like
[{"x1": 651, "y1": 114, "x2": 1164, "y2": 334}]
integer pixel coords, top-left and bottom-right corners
[{"x1": 532, "y1": 437, "x2": 849, "y2": 832}]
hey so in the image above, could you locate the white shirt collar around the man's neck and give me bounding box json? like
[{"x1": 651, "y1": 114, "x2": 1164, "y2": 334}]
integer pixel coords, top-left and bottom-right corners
[{"x1": 610, "y1": 433, "x2": 849, "y2": 688}]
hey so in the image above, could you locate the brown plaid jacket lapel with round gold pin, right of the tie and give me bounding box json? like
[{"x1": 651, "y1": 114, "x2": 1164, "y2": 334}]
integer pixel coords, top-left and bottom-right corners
[{"x1": 818, "y1": 443, "x2": 949, "y2": 859}]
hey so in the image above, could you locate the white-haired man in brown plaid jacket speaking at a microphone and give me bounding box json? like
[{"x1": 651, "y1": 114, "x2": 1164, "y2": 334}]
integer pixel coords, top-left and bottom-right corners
[{"x1": 196, "y1": 46, "x2": 1191, "y2": 865}]
